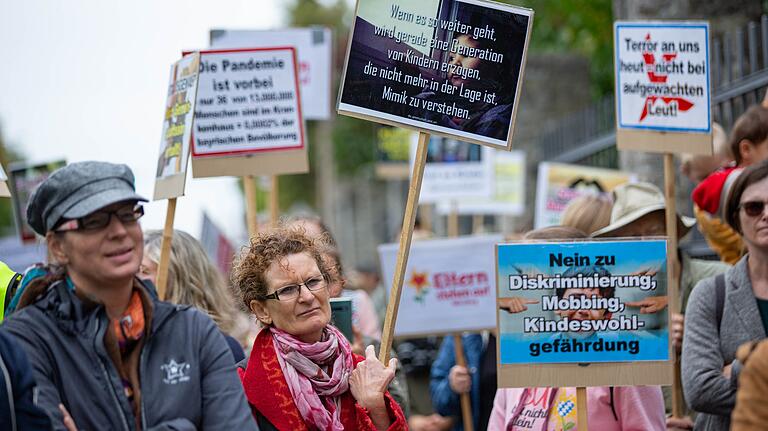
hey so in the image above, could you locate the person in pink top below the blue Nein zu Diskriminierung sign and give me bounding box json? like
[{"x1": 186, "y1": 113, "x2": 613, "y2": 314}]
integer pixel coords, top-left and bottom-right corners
[{"x1": 488, "y1": 386, "x2": 666, "y2": 431}]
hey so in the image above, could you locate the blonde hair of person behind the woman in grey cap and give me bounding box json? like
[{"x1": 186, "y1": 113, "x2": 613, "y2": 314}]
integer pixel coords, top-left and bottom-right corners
[{"x1": 144, "y1": 230, "x2": 238, "y2": 335}]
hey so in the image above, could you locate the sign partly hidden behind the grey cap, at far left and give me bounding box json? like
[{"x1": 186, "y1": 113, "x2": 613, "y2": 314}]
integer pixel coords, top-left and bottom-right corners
[{"x1": 8, "y1": 160, "x2": 66, "y2": 242}]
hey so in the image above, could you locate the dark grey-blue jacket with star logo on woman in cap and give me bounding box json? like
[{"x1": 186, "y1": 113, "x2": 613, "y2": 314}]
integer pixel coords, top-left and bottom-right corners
[{"x1": 4, "y1": 280, "x2": 258, "y2": 431}]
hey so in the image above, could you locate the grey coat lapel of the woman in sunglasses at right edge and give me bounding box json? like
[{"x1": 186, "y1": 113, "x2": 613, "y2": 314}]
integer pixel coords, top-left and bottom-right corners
[{"x1": 726, "y1": 255, "x2": 766, "y2": 339}]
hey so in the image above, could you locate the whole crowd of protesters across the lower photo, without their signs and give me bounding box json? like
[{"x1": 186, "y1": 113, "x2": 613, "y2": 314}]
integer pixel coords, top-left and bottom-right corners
[{"x1": 0, "y1": 106, "x2": 768, "y2": 431}]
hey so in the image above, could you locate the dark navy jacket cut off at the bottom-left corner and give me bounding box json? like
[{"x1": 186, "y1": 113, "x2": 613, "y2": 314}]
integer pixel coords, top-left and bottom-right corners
[{"x1": 0, "y1": 328, "x2": 51, "y2": 431}]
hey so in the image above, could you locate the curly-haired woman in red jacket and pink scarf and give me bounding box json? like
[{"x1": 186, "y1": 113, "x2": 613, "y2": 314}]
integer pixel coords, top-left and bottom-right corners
[{"x1": 232, "y1": 227, "x2": 407, "y2": 431}]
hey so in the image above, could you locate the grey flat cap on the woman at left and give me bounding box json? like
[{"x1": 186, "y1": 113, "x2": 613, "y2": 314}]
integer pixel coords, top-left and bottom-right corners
[{"x1": 27, "y1": 162, "x2": 147, "y2": 235}]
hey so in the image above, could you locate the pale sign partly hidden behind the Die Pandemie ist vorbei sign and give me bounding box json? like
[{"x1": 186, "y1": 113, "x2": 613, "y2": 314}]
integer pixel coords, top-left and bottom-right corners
[{"x1": 211, "y1": 27, "x2": 333, "y2": 120}]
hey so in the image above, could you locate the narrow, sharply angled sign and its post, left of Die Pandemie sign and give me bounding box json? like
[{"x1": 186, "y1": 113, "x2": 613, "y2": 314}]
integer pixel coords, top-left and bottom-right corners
[{"x1": 153, "y1": 52, "x2": 200, "y2": 300}]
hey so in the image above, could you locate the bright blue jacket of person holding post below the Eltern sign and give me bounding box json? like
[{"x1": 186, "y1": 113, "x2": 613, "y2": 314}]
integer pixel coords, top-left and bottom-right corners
[{"x1": 429, "y1": 334, "x2": 483, "y2": 430}]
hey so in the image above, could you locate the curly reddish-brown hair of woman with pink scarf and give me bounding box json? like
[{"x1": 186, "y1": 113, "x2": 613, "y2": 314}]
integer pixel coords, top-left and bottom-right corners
[{"x1": 230, "y1": 226, "x2": 328, "y2": 310}]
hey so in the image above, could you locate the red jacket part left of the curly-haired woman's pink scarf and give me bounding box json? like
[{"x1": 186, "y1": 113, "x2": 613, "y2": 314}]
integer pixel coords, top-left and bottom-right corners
[{"x1": 240, "y1": 329, "x2": 307, "y2": 430}]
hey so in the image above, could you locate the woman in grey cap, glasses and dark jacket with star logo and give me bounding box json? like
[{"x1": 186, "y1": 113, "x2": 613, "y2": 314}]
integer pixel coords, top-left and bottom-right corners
[{"x1": 3, "y1": 162, "x2": 257, "y2": 430}]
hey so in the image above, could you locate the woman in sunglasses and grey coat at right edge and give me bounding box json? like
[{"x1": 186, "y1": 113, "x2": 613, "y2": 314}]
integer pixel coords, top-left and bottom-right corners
[{"x1": 681, "y1": 161, "x2": 768, "y2": 430}]
